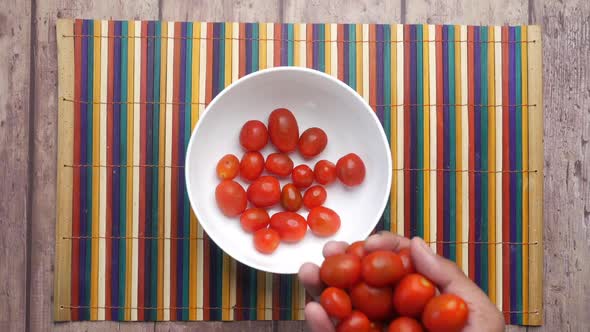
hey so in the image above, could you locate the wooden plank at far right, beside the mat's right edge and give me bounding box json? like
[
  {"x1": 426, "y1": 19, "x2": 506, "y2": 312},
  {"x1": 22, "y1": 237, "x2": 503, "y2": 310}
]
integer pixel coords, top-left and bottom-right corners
[{"x1": 531, "y1": 0, "x2": 590, "y2": 331}]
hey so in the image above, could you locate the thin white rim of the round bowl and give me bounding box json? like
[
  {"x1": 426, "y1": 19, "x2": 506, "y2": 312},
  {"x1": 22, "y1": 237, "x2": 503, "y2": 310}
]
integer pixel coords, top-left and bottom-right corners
[{"x1": 184, "y1": 66, "x2": 393, "y2": 274}]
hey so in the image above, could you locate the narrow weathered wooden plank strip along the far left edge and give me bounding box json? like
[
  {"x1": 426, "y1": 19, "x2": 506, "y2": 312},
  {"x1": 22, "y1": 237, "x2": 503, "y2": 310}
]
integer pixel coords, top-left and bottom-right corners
[{"x1": 0, "y1": 0, "x2": 31, "y2": 331}]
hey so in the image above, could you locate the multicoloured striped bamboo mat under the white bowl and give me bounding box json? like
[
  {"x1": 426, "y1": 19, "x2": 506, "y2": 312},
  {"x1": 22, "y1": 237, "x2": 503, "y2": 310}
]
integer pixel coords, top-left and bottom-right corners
[{"x1": 55, "y1": 20, "x2": 543, "y2": 325}]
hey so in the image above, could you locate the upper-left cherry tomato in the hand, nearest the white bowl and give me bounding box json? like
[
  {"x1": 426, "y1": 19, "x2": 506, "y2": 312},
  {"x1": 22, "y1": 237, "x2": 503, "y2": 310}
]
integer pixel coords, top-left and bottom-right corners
[{"x1": 320, "y1": 254, "x2": 361, "y2": 288}]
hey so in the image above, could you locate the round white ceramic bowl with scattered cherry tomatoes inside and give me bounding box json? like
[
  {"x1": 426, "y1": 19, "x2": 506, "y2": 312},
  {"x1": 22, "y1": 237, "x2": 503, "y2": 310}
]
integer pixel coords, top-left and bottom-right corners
[{"x1": 185, "y1": 67, "x2": 392, "y2": 274}]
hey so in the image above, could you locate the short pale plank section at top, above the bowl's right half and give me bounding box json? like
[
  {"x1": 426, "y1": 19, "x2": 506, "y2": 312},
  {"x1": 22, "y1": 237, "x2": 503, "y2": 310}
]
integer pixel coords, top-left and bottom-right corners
[{"x1": 283, "y1": 0, "x2": 402, "y2": 23}]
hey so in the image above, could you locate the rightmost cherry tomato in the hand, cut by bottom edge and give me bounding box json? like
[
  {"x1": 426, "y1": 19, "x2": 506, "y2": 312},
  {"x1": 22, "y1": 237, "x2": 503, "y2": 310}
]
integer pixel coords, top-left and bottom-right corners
[{"x1": 422, "y1": 294, "x2": 469, "y2": 332}]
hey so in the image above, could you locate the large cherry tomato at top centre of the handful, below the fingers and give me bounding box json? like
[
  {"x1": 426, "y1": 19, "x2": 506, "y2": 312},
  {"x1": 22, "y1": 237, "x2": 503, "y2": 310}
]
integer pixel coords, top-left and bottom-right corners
[{"x1": 362, "y1": 250, "x2": 404, "y2": 287}]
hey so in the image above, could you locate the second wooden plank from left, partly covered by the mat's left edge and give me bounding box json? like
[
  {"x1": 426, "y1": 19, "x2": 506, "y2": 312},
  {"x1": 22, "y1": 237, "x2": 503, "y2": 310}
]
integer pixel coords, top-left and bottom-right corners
[{"x1": 29, "y1": 0, "x2": 158, "y2": 331}]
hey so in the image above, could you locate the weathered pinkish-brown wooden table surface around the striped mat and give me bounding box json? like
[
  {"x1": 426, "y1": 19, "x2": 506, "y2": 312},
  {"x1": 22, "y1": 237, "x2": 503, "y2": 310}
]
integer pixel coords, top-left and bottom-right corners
[{"x1": 0, "y1": 0, "x2": 590, "y2": 331}]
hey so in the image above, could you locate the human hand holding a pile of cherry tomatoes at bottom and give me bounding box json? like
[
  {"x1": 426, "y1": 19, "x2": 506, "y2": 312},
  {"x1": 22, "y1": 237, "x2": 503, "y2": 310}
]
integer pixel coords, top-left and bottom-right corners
[{"x1": 298, "y1": 232, "x2": 504, "y2": 332}]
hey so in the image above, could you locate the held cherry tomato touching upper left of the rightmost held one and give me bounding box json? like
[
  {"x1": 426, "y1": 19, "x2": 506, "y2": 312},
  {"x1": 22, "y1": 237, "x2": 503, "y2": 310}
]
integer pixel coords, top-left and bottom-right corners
[{"x1": 393, "y1": 273, "x2": 436, "y2": 317}]
